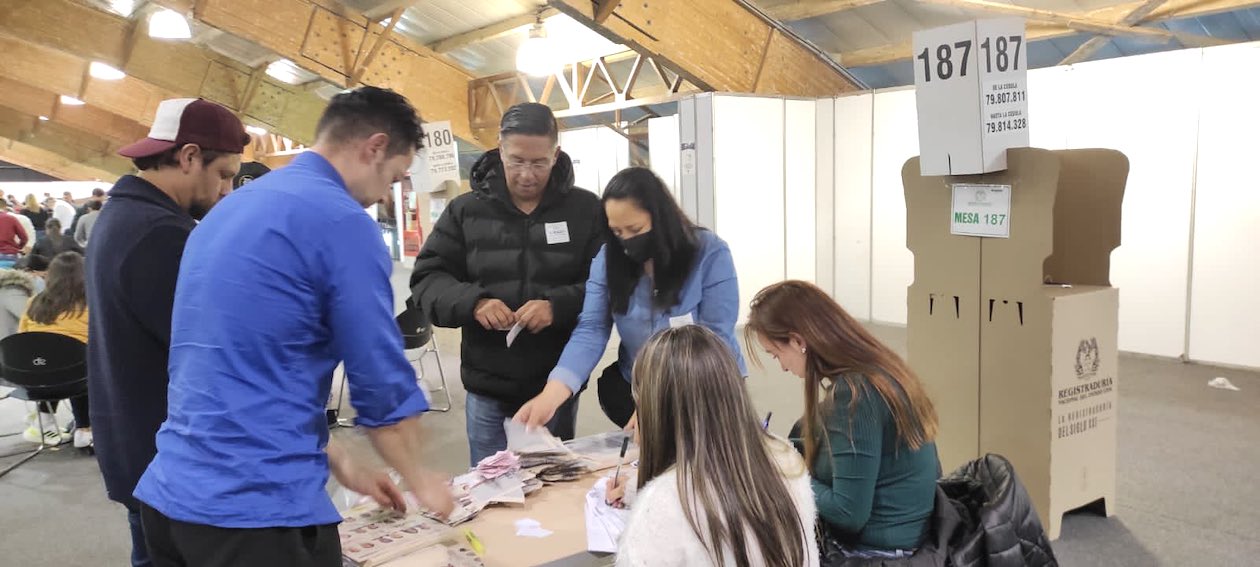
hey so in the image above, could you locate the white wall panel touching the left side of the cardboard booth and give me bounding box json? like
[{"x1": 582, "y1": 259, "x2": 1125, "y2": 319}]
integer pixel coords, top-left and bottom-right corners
[{"x1": 871, "y1": 89, "x2": 919, "y2": 325}]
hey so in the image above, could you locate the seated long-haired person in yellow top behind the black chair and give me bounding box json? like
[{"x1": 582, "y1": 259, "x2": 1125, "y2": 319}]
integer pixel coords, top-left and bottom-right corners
[{"x1": 18, "y1": 252, "x2": 92, "y2": 449}]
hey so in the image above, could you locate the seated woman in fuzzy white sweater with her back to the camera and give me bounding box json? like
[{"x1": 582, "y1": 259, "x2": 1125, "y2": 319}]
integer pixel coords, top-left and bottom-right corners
[{"x1": 609, "y1": 325, "x2": 819, "y2": 567}]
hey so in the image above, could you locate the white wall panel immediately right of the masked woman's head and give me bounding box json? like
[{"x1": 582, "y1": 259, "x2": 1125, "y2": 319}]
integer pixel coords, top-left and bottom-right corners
[{"x1": 713, "y1": 96, "x2": 786, "y2": 321}]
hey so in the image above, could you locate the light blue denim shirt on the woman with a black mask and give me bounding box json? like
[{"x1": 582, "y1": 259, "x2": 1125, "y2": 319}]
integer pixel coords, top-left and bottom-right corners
[{"x1": 548, "y1": 229, "x2": 748, "y2": 392}]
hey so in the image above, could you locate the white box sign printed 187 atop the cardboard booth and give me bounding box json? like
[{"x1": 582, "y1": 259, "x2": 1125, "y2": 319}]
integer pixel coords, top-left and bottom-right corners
[{"x1": 914, "y1": 19, "x2": 1028, "y2": 175}]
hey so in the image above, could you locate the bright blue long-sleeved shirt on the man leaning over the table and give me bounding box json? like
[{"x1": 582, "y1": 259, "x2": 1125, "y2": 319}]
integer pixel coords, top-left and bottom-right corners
[{"x1": 135, "y1": 151, "x2": 428, "y2": 528}]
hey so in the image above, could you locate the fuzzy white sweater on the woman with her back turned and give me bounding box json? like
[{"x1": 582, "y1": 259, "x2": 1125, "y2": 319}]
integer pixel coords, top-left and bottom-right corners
[{"x1": 616, "y1": 441, "x2": 818, "y2": 567}]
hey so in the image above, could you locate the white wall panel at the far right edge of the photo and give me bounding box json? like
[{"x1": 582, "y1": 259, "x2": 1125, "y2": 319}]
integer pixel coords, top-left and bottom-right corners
[{"x1": 1189, "y1": 44, "x2": 1260, "y2": 367}]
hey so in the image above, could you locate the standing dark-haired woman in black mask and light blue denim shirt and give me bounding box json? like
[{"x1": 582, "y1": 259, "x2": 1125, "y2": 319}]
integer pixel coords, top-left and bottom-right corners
[{"x1": 515, "y1": 168, "x2": 747, "y2": 427}]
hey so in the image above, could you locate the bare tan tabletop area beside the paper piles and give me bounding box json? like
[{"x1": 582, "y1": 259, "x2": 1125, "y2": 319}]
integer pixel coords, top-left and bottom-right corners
[{"x1": 383, "y1": 473, "x2": 614, "y2": 567}]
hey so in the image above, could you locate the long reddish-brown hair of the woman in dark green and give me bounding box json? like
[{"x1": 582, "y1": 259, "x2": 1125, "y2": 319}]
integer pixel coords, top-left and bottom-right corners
[{"x1": 743, "y1": 280, "x2": 937, "y2": 466}]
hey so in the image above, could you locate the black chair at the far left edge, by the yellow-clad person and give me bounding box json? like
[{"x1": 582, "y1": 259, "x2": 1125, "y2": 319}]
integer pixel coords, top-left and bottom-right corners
[{"x1": 0, "y1": 333, "x2": 87, "y2": 476}]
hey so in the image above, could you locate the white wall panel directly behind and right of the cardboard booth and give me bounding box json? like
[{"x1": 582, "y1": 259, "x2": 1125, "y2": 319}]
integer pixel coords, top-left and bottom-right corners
[{"x1": 1063, "y1": 50, "x2": 1199, "y2": 357}]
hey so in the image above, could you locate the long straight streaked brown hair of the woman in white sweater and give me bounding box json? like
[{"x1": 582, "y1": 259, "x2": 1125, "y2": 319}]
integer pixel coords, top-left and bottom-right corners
[{"x1": 634, "y1": 325, "x2": 813, "y2": 567}]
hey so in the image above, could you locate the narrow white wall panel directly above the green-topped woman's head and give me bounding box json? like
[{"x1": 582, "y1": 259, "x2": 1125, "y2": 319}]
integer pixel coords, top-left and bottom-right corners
[{"x1": 784, "y1": 101, "x2": 818, "y2": 282}]
